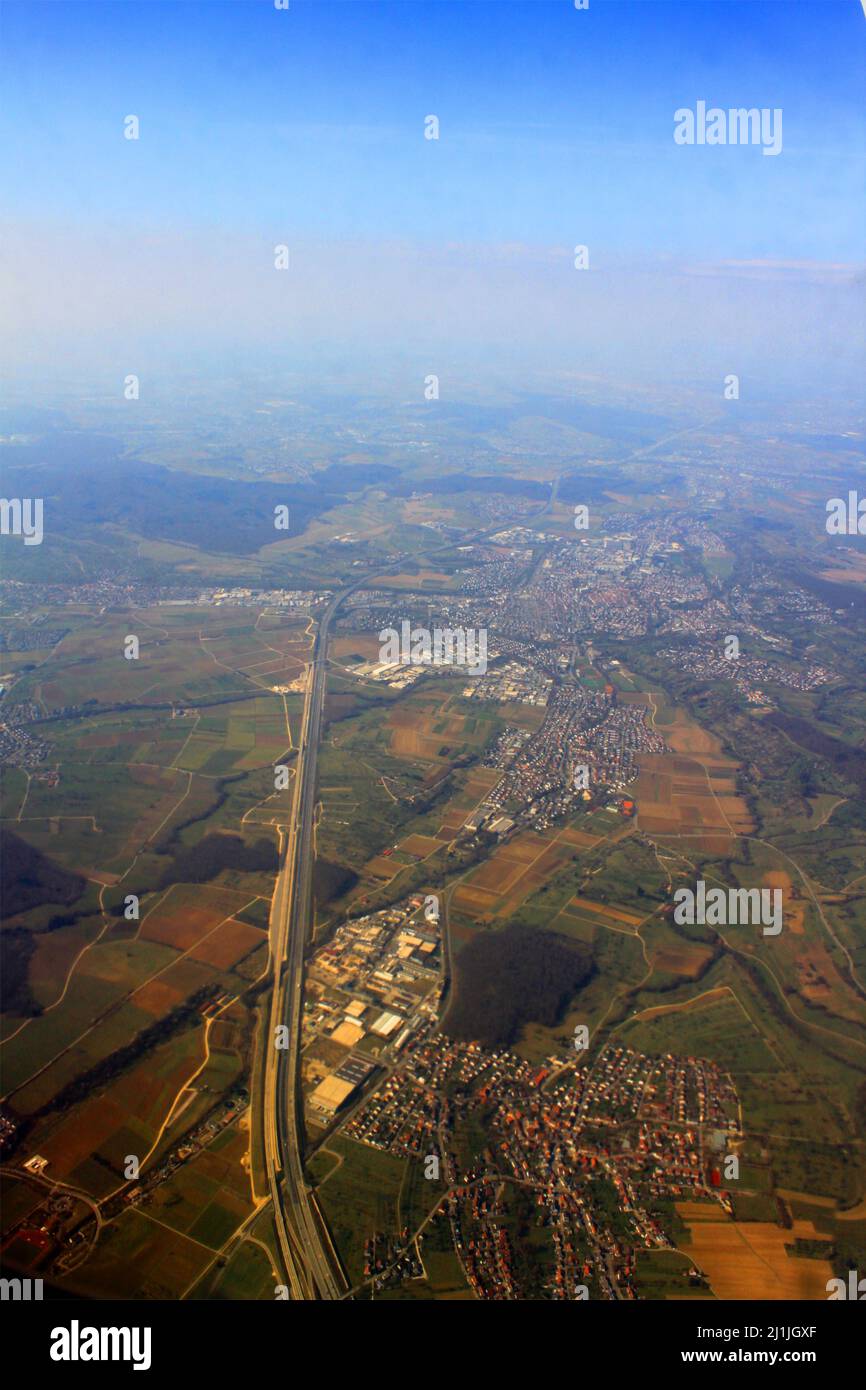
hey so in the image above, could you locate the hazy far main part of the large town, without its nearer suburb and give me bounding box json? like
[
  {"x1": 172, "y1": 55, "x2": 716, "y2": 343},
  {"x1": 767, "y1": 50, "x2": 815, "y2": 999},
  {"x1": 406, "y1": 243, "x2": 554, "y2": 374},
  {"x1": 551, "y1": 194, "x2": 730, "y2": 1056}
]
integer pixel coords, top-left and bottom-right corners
[{"x1": 341, "y1": 512, "x2": 831, "y2": 699}]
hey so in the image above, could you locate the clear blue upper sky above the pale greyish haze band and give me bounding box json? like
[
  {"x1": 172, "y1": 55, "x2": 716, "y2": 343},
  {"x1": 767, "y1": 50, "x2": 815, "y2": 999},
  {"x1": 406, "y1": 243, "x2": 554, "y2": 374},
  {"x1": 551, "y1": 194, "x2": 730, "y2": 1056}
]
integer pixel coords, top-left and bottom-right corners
[{"x1": 0, "y1": 0, "x2": 866, "y2": 391}]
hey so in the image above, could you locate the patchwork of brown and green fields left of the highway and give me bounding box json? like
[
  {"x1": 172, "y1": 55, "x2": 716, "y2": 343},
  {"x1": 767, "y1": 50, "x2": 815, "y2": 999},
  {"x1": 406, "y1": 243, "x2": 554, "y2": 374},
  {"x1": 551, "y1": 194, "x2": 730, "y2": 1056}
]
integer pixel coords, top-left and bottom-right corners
[{"x1": 0, "y1": 607, "x2": 284, "y2": 1256}]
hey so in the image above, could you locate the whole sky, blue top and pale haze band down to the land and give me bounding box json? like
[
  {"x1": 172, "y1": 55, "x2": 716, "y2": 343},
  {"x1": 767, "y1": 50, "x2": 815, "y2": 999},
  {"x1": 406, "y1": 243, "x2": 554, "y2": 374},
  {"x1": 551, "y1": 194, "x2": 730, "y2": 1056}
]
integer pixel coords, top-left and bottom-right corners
[{"x1": 0, "y1": 0, "x2": 866, "y2": 399}]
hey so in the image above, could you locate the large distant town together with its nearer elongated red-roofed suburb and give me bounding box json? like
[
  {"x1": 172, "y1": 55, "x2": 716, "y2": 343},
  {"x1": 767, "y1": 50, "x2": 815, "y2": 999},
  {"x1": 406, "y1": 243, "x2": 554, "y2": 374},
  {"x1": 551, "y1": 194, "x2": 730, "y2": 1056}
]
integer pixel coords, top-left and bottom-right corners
[{"x1": 335, "y1": 512, "x2": 834, "y2": 830}]
